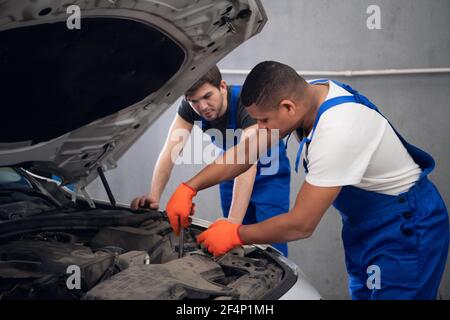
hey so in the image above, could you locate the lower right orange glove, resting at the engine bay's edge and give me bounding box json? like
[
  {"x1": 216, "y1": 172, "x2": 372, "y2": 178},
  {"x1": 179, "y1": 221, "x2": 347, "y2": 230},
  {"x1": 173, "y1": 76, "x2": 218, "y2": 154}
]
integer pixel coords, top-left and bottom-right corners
[{"x1": 197, "y1": 220, "x2": 244, "y2": 256}]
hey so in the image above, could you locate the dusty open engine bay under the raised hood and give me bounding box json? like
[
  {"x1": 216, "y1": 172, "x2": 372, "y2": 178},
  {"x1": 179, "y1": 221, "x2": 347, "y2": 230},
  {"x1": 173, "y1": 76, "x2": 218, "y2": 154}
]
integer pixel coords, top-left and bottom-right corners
[{"x1": 0, "y1": 208, "x2": 295, "y2": 300}]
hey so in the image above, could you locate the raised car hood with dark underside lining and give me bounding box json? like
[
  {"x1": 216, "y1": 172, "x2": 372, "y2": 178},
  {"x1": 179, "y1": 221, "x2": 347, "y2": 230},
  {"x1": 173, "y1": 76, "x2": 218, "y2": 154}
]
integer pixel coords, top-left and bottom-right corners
[{"x1": 0, "y1": 0, "x2": 267, "y2": 187}]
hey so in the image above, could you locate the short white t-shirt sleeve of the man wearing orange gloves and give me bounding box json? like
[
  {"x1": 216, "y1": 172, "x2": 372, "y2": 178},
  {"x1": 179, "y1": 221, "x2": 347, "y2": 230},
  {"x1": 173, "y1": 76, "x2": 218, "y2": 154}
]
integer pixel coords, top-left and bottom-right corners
[{"x1": 303, "y1": 103, "x2": 388, "y2": 187}]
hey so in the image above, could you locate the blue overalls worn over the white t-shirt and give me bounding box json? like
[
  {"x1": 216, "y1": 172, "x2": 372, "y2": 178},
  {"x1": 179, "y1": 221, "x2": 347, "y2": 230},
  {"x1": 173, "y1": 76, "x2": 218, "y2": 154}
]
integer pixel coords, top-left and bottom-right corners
[{"x1": 296, "y1": 80, "x2": 449, "y2": 299}]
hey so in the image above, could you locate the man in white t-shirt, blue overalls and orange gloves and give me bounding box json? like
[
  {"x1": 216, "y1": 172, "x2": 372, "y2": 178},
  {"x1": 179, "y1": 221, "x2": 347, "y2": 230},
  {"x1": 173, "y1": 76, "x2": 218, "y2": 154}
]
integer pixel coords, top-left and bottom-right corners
[{"x1": 167, "y1": 61, "x2": 449, "y2": 299}]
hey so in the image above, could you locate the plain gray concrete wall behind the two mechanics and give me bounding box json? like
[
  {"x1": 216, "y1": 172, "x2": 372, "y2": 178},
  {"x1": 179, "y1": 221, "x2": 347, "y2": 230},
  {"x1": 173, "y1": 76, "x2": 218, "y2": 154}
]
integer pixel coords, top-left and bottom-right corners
[{"x1": 89, "y1": 0, "x2": 450, "y2": 299}]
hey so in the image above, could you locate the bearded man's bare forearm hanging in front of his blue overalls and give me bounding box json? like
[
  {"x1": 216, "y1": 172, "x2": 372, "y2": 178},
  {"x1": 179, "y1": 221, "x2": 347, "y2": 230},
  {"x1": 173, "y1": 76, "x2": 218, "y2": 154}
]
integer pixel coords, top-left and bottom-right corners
[{"x1": 228, "y1": 165, "x2": 256, "y2": 223}]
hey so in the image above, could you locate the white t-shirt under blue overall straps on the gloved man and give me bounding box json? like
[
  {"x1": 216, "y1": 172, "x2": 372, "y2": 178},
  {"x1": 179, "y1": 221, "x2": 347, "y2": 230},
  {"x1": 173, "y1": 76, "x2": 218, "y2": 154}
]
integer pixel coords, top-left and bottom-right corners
[{"x1": 299, "y1": 81, "x2": 421, "y2": 195}]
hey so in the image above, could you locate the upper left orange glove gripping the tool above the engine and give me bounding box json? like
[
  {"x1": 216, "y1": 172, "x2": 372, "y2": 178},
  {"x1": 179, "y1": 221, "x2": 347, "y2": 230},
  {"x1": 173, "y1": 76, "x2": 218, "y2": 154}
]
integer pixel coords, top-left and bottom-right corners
[{"x1": 166, "y1": 182, "x2": 197, "y2": 235}]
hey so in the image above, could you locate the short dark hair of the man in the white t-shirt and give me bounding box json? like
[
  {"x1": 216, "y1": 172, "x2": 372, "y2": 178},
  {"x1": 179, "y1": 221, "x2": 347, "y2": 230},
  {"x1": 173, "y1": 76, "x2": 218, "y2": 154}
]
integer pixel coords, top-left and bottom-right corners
[{"x1": 241, "y1": 61, "x2": 307, "y2": 108}]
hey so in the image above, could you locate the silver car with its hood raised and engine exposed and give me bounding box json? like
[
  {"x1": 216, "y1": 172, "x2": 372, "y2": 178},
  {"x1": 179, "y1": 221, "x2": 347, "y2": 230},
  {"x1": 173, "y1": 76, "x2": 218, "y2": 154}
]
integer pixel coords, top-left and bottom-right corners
[{"x1": 0, "y1": 0, "x2": 320, "y2": 300}]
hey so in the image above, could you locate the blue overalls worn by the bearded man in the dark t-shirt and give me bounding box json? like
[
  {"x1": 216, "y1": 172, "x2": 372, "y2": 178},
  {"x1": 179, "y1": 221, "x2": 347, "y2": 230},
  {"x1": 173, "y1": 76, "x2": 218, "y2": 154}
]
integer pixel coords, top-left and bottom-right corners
[{"x1": 202, "y1": 86, "x2": 291, "y2": 256}]
